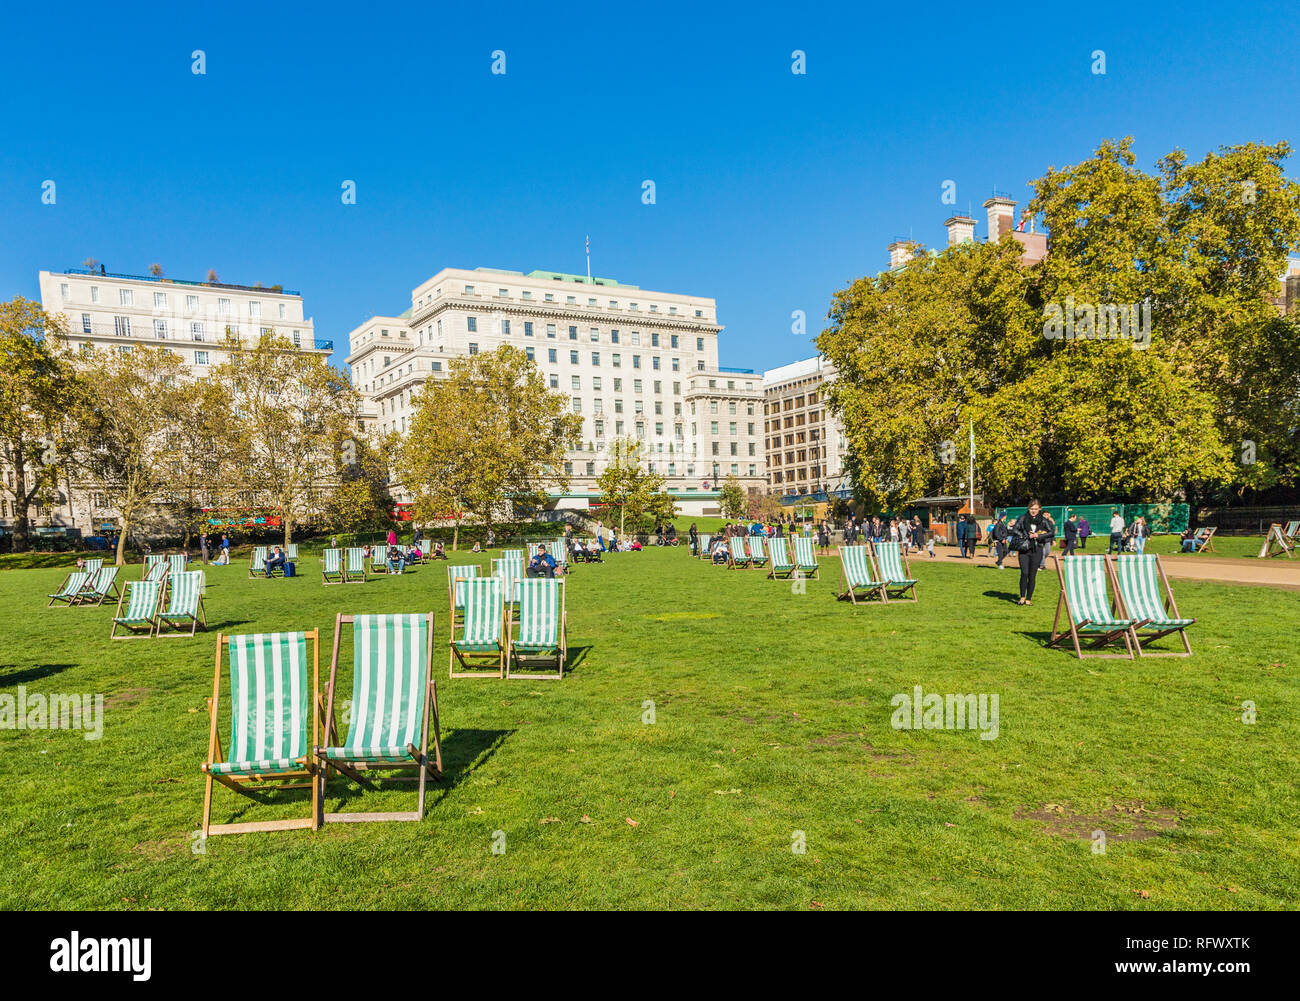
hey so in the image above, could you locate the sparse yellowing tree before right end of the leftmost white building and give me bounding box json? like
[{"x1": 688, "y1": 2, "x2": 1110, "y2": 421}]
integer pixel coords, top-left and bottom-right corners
[{"x1": 212, "y1": 332, "x2": 360, "y2": 546}]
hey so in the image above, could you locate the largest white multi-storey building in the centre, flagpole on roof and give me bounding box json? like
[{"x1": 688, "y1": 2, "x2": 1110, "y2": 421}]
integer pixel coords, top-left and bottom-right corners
[{"x1": 347, "y1": 268, "x2": 764, "y2": 514}]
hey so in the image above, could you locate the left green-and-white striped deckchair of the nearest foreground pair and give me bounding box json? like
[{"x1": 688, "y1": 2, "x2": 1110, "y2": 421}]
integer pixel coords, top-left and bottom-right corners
[{"x1": 200, "y1": 629, "x2": 321, "y2": 837}]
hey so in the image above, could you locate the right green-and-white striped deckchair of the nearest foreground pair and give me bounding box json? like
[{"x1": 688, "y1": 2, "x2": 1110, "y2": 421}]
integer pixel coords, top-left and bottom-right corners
[{"x1": 316, "y1": 612, "x2": 442, "y2": 824}]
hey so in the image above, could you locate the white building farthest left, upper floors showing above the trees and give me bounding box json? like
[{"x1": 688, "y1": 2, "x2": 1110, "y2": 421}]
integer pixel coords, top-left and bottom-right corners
[{"x1": 40, "y1": 269, "x2": 334, "y2": 377}]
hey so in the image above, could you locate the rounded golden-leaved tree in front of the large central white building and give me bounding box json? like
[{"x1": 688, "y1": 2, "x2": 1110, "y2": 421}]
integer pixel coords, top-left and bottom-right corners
[{"x1": 397, "y1": 345, "x2": 582, "y2": 547}]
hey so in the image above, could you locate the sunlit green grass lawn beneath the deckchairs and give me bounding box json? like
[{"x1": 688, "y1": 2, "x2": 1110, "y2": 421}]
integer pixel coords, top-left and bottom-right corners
[{"x1": 0, "y1": 549, "x2": 1300, "y2": 910}]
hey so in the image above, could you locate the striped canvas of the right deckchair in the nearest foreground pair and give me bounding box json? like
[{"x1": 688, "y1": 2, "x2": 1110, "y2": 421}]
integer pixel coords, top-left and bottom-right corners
[{"x1": 322, "y1": 615, "x2": 429, "y2": 762}]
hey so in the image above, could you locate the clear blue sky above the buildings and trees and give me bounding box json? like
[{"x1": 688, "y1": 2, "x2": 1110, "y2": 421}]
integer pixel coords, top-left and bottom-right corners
[{"x1": 0, "y1": 3, "x2": 1300, "y2": 368}]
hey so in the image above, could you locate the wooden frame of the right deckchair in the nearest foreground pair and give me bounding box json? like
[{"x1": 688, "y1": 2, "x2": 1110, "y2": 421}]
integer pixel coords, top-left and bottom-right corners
[{"x1": 316, "y1": 612, "x2": 442, "y2": 824}]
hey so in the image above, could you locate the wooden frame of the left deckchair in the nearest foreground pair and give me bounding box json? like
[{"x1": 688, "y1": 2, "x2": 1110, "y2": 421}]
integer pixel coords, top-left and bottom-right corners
[{"x1": 200, "y1": 629, "x2": 321, "y2": 837}]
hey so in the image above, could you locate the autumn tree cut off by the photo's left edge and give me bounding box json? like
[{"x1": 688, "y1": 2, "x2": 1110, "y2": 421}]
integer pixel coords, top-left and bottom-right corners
[{"x1": 0, "y1": 296, "x2": 74, "y2": 553}]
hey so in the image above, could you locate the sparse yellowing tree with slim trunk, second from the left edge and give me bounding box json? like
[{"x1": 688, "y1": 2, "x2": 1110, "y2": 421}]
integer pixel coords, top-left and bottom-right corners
[{"x1": 72, "y1": 346, "x2": 185, "y2": 566}]
